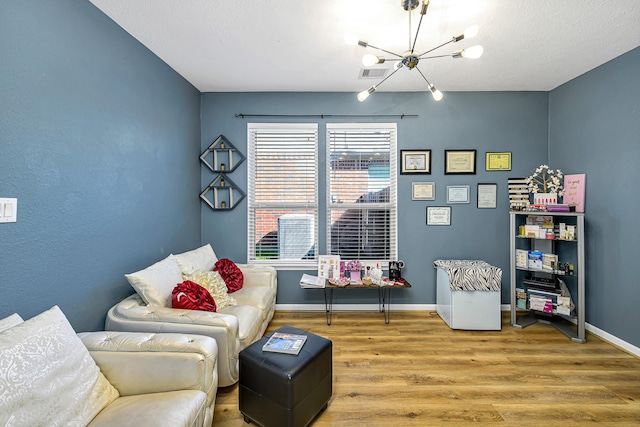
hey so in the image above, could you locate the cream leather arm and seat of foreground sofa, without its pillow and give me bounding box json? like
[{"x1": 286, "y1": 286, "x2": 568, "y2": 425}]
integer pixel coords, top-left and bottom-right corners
[{"x1": 78, "y1": 331, "x2": 218, "y2": 427}]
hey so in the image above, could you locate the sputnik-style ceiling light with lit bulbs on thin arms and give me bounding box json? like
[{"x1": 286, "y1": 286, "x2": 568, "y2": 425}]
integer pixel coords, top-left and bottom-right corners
[{"x1": 346, "y1": 0, "x2": 483, "y2": 102}]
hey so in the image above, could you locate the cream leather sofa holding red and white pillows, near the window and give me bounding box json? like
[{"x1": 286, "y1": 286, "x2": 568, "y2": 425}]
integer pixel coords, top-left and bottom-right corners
[{"x1": 105, "y1": 245, "x2": 277, "y2": 387}]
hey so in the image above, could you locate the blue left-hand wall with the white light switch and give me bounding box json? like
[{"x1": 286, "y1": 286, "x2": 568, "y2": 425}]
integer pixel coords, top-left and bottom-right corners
[{"x1": 0, "y1": 0, "x2": 200, "y2": 331}]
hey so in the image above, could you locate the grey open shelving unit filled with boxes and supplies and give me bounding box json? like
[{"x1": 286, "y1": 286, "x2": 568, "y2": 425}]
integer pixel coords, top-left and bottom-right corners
[{"x1": 509, "y1": 211, "x2": 586, "y2": 343}]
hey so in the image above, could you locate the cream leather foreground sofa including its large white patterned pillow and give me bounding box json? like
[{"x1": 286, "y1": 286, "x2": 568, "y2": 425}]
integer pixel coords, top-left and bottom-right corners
[{"x1": 0, "y1": 306, "x2": 218, "y2": 427}]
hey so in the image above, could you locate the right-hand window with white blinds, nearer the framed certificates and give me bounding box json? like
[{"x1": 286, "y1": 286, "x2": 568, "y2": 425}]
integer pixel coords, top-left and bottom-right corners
[{"x1": 327, "y1": 123, "x2": 397, "y2": 262}]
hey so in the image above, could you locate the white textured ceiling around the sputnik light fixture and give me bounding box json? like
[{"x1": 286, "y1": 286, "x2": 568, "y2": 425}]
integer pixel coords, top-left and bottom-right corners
[{"x1": 90, "y1": 0, "x2": 640, "y2": 92}]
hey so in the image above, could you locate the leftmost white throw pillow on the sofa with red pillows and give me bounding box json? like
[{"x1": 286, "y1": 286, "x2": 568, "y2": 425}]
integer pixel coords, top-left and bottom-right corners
[{"x1": 124, "y1": 255, "x2": 183, "y2": 307}]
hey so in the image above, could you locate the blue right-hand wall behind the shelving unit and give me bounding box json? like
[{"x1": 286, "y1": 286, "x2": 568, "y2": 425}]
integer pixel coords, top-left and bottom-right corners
[{"x1": 549, "y1": 48, "x2": 640, "y2": 346}]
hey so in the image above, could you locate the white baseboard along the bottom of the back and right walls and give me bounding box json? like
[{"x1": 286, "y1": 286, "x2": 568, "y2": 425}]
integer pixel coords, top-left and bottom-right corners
[{"x1": 276, "y1": 304, "x2": 640, "y2": 357}]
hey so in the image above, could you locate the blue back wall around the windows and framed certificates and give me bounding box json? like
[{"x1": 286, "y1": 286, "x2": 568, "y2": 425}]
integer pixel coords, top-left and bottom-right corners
[{"x1": 201, "y1": 92, "x2": 548, "y2": 304}]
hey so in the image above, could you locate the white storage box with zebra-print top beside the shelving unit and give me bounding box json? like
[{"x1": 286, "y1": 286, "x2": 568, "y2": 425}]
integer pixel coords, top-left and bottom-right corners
[{"x1": 433, "y1": 260, "x2": 502, "y2": 330}]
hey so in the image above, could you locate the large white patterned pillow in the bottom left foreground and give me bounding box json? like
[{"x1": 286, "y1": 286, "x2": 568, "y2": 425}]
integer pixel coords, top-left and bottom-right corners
[{"x1": 0, "y1": 306, "x2": 119, "y2": 426}]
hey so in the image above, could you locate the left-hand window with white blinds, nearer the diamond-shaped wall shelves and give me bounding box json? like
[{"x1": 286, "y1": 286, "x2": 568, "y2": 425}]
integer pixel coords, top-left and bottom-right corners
[{"x1": 247, "y1": 123, "x2": 318, "y2": 266}]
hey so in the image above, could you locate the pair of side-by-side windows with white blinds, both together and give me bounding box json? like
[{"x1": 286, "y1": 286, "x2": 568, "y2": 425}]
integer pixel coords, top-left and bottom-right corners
[{"x1": 247, "y1": 123, "x2": 398, "y2": 267}]
